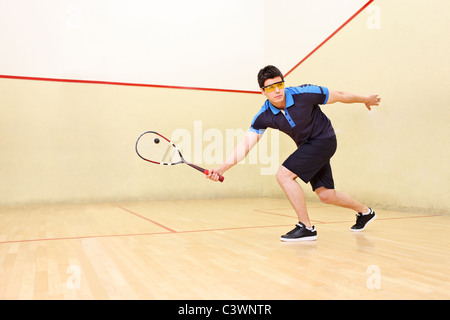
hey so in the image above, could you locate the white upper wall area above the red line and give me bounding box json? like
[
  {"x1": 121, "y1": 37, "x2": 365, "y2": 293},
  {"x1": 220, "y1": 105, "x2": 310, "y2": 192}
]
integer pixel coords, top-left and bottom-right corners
[{"x1": 0, "y1": 0, "x2": 367, "y2": 91}]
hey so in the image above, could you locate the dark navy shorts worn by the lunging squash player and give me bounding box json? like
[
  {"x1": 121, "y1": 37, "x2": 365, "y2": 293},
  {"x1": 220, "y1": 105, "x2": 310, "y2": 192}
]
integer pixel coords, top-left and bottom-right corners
[{"x1": 283, "y1": 136, "x2": 337, "y2": 191}]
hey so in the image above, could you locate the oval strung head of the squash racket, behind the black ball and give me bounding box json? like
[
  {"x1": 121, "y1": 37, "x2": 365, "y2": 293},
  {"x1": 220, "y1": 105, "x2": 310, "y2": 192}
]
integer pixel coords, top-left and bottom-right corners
[{"x1": 135, "y1": 131, "x2": 184, "y2": 166}]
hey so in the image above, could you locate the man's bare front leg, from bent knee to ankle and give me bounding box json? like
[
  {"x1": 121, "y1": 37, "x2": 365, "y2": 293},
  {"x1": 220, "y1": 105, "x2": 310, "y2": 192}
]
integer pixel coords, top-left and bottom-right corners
[{"x1": 276, "y1": 166, "x2": 312, "y2": 228}]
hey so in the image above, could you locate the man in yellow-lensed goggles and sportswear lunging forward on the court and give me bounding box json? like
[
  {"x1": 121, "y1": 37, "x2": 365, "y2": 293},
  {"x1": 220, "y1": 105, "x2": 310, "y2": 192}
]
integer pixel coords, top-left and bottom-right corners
[{"x1": 207, "y1": 66, "x2": 380, "y2": 241}]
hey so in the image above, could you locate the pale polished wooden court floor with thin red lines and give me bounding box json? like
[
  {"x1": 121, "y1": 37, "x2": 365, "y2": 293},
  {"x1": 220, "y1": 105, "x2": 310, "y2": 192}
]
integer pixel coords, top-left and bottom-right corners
[{"x1": 0, "y1": 199, "x2": 450, "y2": 300}]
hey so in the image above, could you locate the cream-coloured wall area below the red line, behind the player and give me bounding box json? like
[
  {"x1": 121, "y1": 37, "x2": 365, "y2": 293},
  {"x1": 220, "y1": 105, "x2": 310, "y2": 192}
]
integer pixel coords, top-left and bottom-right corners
[{"x1": 0, "y1": 0, "x2": 450, "y2": 214}]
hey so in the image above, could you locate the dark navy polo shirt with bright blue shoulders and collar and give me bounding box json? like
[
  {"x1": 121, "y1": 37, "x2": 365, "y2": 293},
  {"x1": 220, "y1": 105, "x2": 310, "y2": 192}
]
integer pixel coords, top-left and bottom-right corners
[{"x1": 250, "y1": 84, "x2": 335, "y2": 146}]
